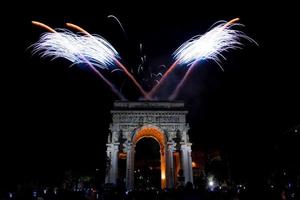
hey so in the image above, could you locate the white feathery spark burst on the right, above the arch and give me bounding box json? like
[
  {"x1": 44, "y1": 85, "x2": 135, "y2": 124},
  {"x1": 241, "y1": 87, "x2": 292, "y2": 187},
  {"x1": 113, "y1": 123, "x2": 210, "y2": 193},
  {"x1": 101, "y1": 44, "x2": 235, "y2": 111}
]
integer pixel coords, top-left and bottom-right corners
[{"x1": 173, "y1": 21, "x2": 256, "y2": 67}]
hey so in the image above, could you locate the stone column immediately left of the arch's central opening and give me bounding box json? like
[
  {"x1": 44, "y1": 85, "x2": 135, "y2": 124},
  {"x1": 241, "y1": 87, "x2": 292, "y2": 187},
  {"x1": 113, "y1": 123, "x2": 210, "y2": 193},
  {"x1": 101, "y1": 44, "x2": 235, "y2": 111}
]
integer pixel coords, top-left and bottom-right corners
[{"x1": 125, "y1": 144, "x2": 135, "y2": 191}]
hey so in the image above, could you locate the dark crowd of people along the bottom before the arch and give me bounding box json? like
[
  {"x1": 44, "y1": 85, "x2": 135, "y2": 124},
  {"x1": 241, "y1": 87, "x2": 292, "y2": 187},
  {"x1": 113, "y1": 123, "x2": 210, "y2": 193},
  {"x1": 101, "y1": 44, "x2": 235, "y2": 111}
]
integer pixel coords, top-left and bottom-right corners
[{"x1": 1, "y1": 182, "x2": 299, "y2": 200}]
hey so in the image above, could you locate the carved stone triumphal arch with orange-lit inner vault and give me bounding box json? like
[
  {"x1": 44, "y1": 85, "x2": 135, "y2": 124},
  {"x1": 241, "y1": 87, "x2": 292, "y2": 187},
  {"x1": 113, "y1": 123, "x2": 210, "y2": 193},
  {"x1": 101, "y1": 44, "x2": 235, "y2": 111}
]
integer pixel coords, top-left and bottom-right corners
[{"x1": 105, "y1": 101, "x2": 193, "y2": 190}]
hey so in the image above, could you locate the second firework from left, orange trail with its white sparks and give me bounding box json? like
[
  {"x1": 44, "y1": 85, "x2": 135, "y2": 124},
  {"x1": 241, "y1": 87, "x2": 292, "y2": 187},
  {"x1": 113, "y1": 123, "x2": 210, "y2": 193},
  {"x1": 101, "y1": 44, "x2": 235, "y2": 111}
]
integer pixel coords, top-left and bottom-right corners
[{"x1": 66, "y1": 23, "x2": 149, "y2": 99}]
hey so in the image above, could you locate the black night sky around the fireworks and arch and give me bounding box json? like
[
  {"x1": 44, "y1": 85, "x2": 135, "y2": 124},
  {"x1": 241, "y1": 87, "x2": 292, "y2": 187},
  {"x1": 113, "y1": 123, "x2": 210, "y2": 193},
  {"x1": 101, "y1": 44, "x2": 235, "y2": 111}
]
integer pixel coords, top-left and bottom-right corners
[{"x1": 0, "y1": 1, "x2": 300, "y2": 191}]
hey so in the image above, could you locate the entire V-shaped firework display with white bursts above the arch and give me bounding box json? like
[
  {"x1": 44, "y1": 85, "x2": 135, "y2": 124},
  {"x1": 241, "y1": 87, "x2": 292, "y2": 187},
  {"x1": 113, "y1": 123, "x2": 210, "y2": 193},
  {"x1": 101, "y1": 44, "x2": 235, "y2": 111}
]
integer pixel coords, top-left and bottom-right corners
[{"x1": 32, "y1": 15, "x2": 255, "y2": 100}]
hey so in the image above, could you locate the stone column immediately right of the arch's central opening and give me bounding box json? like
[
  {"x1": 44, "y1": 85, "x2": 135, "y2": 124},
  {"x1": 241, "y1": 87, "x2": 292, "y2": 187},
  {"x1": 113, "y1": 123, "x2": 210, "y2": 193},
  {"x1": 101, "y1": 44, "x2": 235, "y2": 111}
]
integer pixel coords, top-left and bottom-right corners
[{"x1": 166, "y1": 142, "x2": 175, "y2": 188}]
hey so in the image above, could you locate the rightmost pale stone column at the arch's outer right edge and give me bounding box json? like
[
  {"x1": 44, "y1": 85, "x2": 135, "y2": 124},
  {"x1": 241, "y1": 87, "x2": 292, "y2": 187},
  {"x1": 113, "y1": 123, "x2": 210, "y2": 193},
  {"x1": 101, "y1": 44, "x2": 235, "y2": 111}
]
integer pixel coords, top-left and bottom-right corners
[{"x1": 180, "y1": 142, "x2": 193, "y2": 183}]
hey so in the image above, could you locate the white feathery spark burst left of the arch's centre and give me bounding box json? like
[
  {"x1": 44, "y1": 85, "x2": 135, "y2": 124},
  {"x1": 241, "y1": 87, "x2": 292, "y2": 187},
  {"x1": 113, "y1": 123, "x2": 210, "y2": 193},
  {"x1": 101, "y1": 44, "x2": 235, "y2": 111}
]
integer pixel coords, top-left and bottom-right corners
[{"x1": 33, "y1": 29, "x2": 120, "y2": 69}]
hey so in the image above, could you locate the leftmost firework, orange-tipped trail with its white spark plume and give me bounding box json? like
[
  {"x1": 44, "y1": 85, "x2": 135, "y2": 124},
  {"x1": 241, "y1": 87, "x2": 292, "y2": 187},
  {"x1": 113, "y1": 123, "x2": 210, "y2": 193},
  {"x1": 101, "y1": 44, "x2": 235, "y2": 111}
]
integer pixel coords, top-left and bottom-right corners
[{"x1": 32, "y1": 21, "x2": 125, "y2": 100}]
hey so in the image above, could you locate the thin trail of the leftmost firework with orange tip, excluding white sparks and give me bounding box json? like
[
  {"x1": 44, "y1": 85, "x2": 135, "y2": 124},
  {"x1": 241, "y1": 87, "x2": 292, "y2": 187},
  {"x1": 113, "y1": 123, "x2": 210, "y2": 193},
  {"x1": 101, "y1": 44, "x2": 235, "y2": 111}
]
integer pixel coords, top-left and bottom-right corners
[{"x1": 32, "y1": 21, "x2": 126, "y2": 100}]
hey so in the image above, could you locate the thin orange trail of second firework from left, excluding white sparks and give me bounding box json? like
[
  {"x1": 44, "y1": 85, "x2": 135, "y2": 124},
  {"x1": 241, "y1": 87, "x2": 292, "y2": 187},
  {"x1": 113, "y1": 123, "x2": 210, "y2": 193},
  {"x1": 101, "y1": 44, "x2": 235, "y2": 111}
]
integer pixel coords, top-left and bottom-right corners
[{"x1": 66, "y1": 23, "x2": 150, "y2": 100}]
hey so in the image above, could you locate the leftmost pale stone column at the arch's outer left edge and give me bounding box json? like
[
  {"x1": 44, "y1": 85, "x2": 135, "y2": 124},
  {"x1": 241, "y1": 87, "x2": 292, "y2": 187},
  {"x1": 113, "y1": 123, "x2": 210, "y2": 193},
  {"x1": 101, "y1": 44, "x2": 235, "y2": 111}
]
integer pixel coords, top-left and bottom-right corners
[{"x1": 105, "y1": 143, "x2": 119, "y2": 184}]
